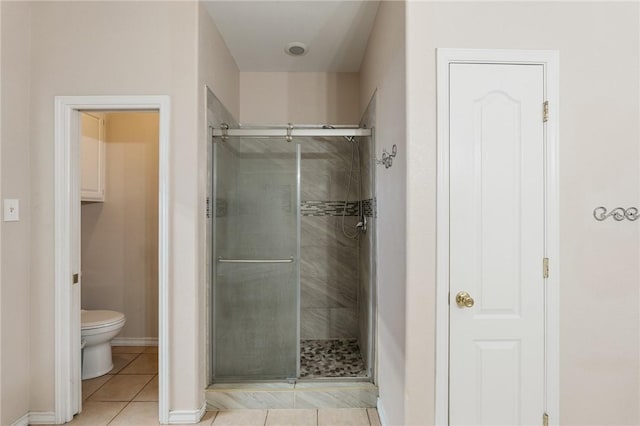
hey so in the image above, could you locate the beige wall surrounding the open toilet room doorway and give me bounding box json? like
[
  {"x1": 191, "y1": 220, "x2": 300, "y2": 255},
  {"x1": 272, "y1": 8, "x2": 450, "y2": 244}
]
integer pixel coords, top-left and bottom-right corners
[{"x1": 27, "y1": 2, "x2": 201, "y2": 411}]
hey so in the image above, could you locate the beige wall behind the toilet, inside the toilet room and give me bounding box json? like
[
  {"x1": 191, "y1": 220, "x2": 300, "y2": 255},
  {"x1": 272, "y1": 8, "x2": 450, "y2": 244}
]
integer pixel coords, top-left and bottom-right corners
[{"x1": 81, "y1": 112, "x2": 158, "y2": 338}]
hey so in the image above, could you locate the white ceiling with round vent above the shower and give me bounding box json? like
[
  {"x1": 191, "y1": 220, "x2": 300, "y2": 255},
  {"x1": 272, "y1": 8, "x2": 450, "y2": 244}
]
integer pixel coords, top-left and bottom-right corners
[{"x1": 203, "y1": 0, "x2": 379, "y2": 72}]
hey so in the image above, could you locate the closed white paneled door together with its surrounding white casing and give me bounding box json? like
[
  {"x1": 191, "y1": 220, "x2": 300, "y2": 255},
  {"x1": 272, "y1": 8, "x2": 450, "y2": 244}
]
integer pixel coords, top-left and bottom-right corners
[{"x1": 436, "y1": 49, "x2": 558, "y2": 425}]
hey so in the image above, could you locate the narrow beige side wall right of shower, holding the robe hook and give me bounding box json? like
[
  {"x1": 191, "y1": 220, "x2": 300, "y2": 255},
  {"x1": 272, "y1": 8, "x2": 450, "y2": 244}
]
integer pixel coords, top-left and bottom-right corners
[{"x1": 359, "y1": 1, "x2": 408, "y2": 425}]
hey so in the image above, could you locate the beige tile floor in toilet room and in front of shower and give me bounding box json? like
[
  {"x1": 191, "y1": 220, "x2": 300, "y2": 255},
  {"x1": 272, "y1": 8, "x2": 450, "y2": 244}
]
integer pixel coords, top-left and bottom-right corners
[{"x1": 70, "y1": 346, "x2": 380, "y2": 426}]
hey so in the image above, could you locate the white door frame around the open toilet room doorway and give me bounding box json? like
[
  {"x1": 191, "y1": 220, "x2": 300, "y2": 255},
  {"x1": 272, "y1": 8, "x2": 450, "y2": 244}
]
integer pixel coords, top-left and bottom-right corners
[{"x1": 54, "y1": 95, "x2": 171, "y2": 424}]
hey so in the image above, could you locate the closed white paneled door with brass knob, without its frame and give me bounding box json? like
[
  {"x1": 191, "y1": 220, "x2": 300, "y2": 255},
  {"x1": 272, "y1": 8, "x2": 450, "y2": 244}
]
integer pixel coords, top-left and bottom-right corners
[{"x1": 449, "y1": 63, "x2": 545, "y2": 426}]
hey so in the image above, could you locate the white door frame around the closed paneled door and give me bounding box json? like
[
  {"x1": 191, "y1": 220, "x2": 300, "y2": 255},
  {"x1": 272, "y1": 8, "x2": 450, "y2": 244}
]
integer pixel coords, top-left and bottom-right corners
[{"x1": 435, "y1": 49, "x2": 560, "y2": 425}]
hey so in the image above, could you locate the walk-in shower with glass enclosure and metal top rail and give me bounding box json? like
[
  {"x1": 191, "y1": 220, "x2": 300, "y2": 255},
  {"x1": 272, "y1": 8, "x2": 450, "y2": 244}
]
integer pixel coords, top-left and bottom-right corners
[{"x1": 209, "y1": 117, "x2": 375, "y2": 384}]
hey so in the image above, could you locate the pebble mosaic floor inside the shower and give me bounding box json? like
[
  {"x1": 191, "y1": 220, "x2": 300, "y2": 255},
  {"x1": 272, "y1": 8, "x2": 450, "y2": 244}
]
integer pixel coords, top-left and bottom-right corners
[{"x1": 300, "y1": 339, "x2": 367, "y2": 379}]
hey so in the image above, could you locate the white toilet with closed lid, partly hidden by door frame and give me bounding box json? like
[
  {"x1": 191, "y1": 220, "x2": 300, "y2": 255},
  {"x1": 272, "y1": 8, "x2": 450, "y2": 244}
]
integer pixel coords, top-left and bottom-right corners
[{"x1": 80, "y1": 309, "x2": 127, "y2": 380}]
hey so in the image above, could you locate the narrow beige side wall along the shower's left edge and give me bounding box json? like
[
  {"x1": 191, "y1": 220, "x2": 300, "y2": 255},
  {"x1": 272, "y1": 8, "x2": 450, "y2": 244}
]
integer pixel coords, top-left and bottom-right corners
[{"x1": 196, "y1": 3, "x2": 240, "y2": 404}]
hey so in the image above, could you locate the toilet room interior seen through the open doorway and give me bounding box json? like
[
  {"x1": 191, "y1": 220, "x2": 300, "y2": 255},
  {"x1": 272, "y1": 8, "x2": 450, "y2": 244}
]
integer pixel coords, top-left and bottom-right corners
[{"x1": 78, "y1": 111, "x2": 159, "y2": 406}]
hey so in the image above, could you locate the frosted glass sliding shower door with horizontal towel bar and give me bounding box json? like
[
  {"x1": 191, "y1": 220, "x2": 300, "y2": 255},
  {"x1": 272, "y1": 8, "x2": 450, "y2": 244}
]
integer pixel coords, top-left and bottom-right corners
[{"x1": 212, "y1": 137, "x2": 300, "y2": 382}]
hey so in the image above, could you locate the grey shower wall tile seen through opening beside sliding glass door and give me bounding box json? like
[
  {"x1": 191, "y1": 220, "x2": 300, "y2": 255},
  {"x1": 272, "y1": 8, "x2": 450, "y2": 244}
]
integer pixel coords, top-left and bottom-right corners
[{"x1": 300, "y1": 133, "x2": 359, "y2": 339}]
